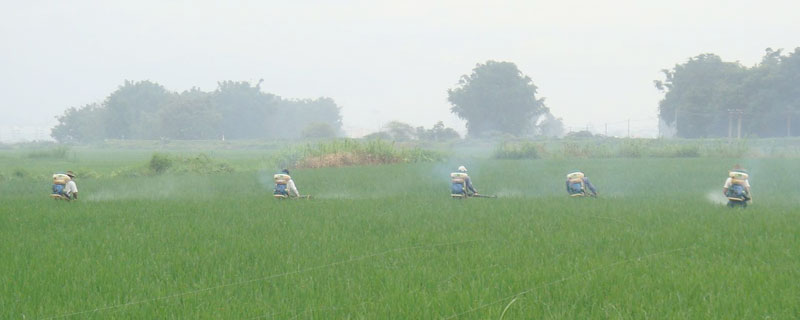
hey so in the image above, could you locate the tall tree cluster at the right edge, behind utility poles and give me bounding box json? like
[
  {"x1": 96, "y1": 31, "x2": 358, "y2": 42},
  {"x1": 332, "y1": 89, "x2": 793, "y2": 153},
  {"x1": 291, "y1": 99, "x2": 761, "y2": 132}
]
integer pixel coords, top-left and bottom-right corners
[{"x1": 655, "y1": 48, "x2": 800, "y2": 138}]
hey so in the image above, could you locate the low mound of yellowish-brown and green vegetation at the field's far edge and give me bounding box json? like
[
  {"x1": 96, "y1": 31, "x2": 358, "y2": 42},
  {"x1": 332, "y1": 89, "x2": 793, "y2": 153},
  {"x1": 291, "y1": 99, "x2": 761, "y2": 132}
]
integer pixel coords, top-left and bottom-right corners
[{"x1": 274, "y1": 139, "x2": 444, "y2": 168}]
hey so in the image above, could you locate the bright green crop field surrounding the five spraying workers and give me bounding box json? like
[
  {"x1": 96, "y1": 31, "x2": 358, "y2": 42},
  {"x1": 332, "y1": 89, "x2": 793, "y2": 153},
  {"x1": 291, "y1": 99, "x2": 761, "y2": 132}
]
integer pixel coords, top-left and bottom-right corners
[{"x1": 0, "y1": 148, "x2": 800, "y2": 319}]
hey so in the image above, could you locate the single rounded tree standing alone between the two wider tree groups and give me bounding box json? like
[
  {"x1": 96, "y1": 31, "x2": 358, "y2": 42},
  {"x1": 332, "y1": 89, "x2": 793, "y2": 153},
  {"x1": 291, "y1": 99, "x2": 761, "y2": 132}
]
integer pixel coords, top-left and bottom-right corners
[{"x1": 447, "y1": 60, "x2": 548, "y2": 136}]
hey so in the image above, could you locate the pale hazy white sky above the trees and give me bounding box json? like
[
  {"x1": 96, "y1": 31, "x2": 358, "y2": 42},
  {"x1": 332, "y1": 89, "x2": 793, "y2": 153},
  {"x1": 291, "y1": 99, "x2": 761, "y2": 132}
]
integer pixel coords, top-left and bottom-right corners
[{"x1": 0, "y1": 0, "x2": 800, "y2": 136}]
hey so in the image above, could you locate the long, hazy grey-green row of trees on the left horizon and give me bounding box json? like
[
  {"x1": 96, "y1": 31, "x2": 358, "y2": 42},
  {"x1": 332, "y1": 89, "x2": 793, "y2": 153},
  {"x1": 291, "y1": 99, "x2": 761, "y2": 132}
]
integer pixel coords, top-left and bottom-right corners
[{"x1": 50, "y1": 81, "x2": 342, "y2": 142}]
